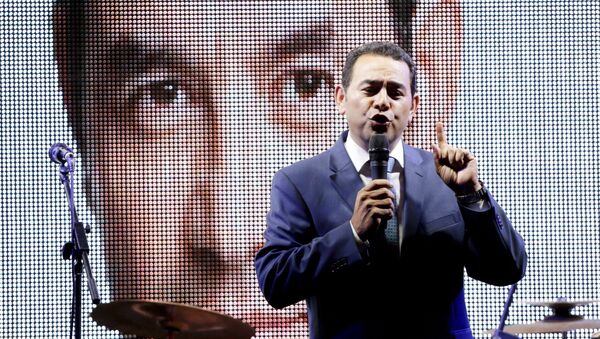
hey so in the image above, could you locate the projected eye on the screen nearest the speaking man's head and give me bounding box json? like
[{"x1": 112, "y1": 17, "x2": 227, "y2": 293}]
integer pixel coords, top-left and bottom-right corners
[{"x1": 284, "y1": 70, "x2": 332, "y2": 101}]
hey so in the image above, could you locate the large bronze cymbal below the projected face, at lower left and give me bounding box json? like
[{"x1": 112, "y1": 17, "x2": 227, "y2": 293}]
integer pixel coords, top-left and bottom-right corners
[{"x1": 90, "y1": 300, "x2": 255, "y2": 339}]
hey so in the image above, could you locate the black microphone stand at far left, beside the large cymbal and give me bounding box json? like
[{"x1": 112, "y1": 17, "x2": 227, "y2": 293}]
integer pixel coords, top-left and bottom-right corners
[{"x1": 58, "y1": 155, "x2": 100, "y2": 339}]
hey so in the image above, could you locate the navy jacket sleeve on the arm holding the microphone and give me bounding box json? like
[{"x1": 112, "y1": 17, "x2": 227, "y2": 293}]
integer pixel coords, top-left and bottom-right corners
[{"x1": 255, "y1": 171, "x2": 364, "y2": 308}]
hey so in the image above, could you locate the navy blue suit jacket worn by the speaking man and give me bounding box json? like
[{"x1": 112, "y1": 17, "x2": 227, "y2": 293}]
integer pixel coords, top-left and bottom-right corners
[{"x1": 255, "y1": 131, "x2": 527, "y2": 339}]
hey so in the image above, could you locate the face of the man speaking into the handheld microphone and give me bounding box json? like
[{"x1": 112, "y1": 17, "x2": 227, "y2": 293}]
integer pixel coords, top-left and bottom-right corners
[{"x1": 336, "y1": 54, "x2": 419, "y2": 149}]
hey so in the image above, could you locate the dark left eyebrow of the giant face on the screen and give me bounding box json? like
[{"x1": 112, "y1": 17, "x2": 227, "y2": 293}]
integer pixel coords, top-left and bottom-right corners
[{"x1": 105, "y1": 37, "x2": 188, "y2": 78}]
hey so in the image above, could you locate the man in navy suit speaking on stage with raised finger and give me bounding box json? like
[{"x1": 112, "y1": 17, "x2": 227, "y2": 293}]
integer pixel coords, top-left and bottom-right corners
[{"x1": 255, "y1": 42, "x2": 527, "y2": 339}]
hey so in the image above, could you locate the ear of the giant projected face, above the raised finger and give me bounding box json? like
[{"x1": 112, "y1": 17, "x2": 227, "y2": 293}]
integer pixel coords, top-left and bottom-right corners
[{"x1": 408, "y1": 0, "x2": 463, "y2": 147}]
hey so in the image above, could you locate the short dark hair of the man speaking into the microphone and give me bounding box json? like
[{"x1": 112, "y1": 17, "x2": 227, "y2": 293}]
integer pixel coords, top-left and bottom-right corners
[{"x1": 342, "y1": 41, "x2": 417, "y2": 96}]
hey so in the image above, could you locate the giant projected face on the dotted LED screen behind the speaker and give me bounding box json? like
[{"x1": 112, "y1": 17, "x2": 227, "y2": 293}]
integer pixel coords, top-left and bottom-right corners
[{"x1": 56, "y1": 0, "x2": 460, "y2": 336}]
